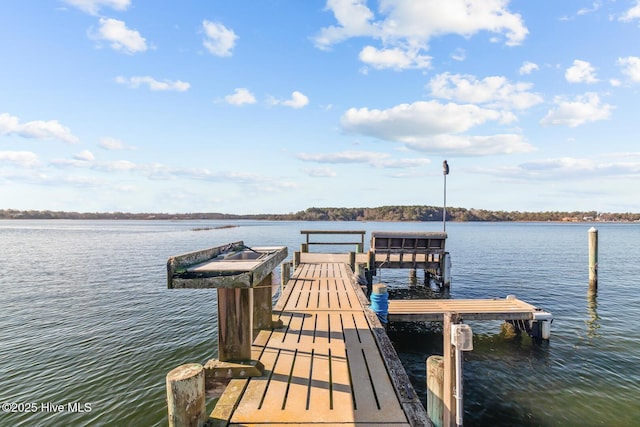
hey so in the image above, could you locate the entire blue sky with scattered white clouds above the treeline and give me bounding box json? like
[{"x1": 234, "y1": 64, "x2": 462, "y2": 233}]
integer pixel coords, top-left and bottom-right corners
[{"x1": 0, "y1": 0, "x2": 640, "y2": 213}]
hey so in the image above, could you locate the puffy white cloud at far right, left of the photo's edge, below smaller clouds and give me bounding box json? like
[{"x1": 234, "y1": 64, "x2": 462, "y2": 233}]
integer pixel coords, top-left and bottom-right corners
[{"x1": 540, "y1": 93, "x2": 614, "y2": 127}]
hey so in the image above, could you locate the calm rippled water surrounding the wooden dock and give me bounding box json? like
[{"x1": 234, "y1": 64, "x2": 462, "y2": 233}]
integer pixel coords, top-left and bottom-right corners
[{"x1": 0, "y1": 220, "x2": 640, "y2": 427}]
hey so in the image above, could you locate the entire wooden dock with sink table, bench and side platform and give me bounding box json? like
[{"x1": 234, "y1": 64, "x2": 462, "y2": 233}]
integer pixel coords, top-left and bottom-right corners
[{"x1": 167, "y1": 237, "x2": 552, "y2": 427}]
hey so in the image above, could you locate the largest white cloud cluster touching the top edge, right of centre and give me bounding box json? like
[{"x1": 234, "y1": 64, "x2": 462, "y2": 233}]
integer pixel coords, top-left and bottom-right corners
[{"x1": 313, "y1": 0, "x2": 528, "y2": 69}]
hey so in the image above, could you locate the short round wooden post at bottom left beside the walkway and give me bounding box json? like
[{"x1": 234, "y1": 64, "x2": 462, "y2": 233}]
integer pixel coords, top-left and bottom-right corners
[{"x1": 166, "y1": 363, "x2": 207, "y2": 427}]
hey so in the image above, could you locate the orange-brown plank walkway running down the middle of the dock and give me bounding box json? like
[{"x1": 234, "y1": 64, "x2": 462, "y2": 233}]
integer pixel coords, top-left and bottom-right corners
[{"x1": 211, "y1": 261, "x2": 431, "y2": 427}]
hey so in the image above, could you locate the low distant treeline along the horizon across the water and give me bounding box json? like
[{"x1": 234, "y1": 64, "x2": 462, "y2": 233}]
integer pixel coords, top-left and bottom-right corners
[{"x1": 0, "y1": 205, "x2": 640, "y2": 222}]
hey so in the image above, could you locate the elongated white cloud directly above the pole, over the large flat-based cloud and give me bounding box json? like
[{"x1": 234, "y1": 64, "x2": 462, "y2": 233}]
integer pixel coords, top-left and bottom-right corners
[{"x1": 428, "y1": 73, "x2": 543, "y2": 110}]
